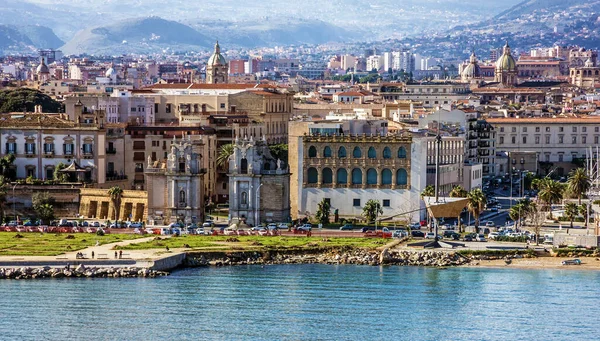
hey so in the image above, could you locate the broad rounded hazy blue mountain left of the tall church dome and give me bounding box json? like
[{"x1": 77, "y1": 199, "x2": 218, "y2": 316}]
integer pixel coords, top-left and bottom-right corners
[{"x1": 61, "y1": 17, "x2": 213, "y2": 55}]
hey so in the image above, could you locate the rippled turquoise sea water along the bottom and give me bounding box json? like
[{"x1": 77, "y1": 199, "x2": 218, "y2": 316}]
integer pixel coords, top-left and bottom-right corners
[{"x1": 0, "y1": 265, "x2": 600, "y2": 340}]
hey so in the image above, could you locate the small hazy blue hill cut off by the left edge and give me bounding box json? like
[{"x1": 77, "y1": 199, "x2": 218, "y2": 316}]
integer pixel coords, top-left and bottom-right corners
[{"x1": 0, "y1": 25, "x2": 64, "y2": 54}]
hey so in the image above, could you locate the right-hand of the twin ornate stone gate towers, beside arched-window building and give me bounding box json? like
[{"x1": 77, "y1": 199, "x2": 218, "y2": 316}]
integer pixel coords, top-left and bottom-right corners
[{"x1": 228, "y1": 137, "x2": 290, "y2": 226}]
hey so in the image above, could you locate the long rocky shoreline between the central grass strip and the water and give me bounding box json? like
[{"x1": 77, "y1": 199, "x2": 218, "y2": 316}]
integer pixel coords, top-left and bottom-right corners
[{"x1": 183, "y1": 249, "x2": 471, "y2": 267}]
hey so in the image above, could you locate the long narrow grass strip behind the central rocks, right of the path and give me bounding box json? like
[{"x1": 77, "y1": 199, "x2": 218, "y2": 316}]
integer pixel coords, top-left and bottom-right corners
[{"x1": 119, "y1": 235, "x2": 392, "y2": 251}]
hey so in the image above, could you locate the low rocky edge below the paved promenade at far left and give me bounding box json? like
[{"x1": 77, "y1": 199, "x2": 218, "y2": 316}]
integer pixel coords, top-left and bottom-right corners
[{"x1": 0, "y1": 265, "x2": 169, "y2": 279}]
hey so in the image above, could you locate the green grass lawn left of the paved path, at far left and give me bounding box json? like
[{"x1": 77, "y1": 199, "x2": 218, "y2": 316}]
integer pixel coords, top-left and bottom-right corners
[{"x1": 0, "y1": 232, "x2": 141, "y2": 256}]
